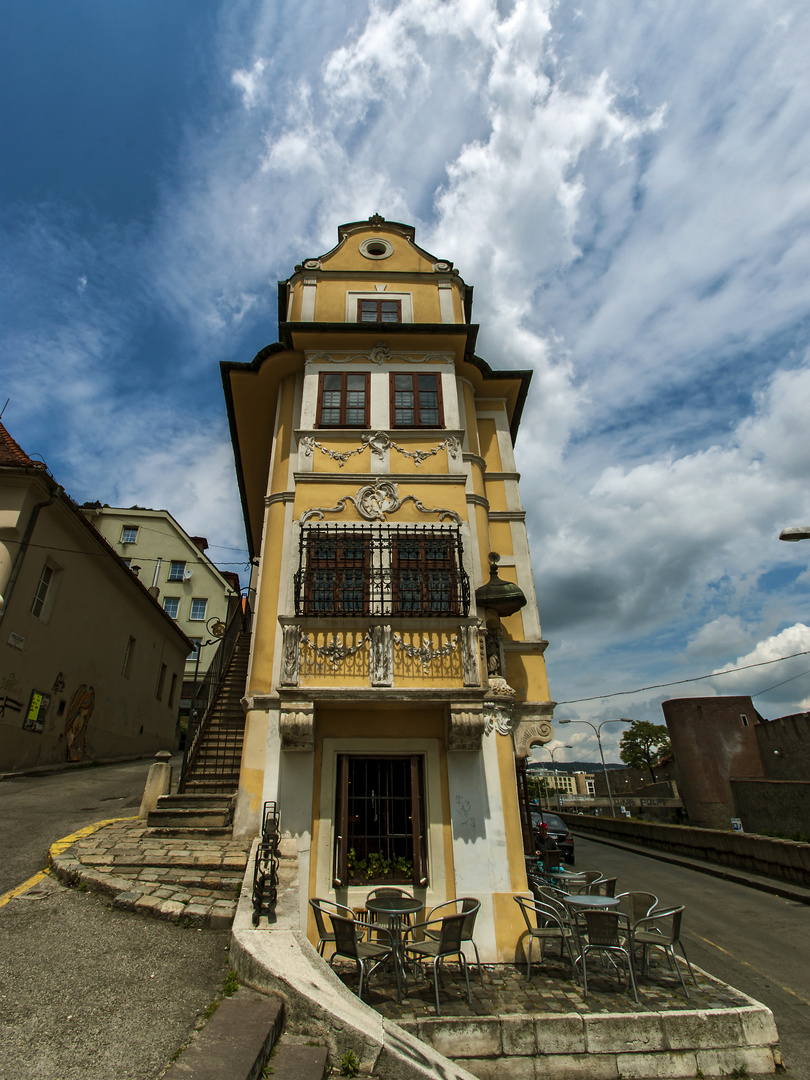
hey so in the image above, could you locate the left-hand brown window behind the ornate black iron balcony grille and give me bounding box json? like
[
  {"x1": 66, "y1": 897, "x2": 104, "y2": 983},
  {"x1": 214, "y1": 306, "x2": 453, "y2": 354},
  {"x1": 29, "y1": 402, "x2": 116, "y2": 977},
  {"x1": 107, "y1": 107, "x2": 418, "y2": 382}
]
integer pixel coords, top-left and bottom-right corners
[{"x1": 302, "y1": 529, "x2": 369, "y2": 616}]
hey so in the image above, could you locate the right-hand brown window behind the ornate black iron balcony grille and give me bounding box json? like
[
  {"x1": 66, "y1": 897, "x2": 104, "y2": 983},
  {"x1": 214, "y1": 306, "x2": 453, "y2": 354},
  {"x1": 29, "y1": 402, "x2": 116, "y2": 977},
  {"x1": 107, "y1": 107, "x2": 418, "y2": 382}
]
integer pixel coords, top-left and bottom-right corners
[{"x1": 391, "y1": 532, "x2": 460, "y2": 616}]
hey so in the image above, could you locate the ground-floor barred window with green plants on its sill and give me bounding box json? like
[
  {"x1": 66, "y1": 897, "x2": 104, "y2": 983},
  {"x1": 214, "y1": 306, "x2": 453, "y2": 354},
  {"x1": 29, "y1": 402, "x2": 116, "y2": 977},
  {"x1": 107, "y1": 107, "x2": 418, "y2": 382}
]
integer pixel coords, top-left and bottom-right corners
[{"x1": 334, "y1": 754, "x2": 428, "y2": 888}]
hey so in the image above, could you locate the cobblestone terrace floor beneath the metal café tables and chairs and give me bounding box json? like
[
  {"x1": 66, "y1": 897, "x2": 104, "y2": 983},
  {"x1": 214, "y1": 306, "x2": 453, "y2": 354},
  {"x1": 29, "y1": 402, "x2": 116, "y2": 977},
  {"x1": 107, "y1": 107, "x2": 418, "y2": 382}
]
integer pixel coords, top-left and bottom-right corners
[{"x1": 335, "y1": 954, "x2": 750, "y2": 1025}]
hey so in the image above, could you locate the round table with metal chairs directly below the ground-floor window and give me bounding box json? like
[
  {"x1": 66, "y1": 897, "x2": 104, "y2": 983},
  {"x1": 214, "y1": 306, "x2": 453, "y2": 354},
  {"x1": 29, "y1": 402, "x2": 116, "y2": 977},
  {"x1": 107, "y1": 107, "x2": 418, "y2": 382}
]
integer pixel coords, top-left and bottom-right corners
[{"x1": 310, "y1": 888, "x2": 483, "y2": 1015}]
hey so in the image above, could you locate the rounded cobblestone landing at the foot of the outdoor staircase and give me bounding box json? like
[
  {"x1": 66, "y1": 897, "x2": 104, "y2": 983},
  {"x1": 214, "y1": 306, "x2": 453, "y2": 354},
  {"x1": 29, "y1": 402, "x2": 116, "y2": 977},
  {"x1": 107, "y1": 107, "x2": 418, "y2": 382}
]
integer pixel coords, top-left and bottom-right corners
[{"x1": 53, "y1": 819, "x2": 251, "y2": 930}]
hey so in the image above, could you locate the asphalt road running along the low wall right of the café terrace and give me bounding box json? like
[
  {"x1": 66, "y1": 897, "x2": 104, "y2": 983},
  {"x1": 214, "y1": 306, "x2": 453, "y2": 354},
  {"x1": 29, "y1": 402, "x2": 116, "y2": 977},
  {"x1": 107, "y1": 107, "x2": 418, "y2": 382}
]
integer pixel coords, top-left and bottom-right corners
[{"x1": 576, "y1": 836, "x2": 810, "y2": 1080}]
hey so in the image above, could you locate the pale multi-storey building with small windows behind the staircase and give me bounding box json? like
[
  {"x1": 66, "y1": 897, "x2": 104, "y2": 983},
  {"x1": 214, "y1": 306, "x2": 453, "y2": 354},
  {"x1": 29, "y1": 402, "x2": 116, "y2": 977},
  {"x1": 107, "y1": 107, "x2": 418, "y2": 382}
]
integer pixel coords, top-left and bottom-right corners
[{"x1": 82, "y1": 503, "x2": 239, "y2": 713}]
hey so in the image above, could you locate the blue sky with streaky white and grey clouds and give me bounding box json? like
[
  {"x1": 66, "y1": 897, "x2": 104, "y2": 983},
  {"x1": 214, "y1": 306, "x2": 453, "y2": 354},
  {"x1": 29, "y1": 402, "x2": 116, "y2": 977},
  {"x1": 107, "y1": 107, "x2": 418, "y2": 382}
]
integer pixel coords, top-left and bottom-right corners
[{"x1": 0, "y1": 0, "x2": 810, "y2": 759}]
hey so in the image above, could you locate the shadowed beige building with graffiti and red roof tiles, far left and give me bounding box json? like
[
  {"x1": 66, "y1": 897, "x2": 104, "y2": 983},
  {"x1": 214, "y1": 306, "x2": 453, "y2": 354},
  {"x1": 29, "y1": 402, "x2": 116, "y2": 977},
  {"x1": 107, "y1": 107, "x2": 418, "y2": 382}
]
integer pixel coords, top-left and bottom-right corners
[{"x1": 0, "y1": 423, "x2": 190, "y2": 771}]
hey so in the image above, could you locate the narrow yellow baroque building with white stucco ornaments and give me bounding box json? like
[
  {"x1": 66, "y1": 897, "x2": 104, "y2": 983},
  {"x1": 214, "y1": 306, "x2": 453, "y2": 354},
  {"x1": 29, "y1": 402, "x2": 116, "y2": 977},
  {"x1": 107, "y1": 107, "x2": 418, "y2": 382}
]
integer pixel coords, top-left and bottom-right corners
[{"x1": 222, "y1": 215, "x2": 552, "y2": 962}]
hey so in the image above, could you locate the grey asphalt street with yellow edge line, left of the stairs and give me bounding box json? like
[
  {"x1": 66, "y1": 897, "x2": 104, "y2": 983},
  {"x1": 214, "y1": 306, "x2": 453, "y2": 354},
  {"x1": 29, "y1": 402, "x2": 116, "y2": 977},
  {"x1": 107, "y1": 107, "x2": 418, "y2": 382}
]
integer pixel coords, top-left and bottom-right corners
[{"x1": 0, "y1": 760, "x2": 230, "y2": 1080}]
